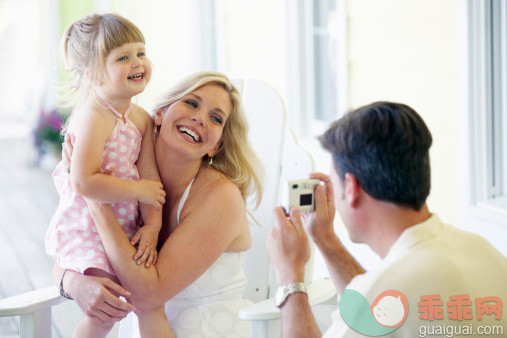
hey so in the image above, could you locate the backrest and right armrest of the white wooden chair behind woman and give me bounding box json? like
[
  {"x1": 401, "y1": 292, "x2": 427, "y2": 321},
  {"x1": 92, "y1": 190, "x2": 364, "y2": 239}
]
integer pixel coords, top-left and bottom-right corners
[{"x1": 235, "y1": 80, "x2": 336, "y2": 338}]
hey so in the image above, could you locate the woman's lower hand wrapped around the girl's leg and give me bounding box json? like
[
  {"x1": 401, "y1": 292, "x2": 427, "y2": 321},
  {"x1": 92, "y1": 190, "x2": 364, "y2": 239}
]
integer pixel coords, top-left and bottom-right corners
[{"x1": 64, "y1": 270, "x2": 135, "y2": 324}]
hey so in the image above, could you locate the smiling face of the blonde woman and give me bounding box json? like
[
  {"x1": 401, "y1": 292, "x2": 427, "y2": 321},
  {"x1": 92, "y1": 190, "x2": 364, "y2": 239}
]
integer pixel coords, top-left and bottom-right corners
[{"x1": 155, "y1": 84, "x2": 232, "y2": 158}]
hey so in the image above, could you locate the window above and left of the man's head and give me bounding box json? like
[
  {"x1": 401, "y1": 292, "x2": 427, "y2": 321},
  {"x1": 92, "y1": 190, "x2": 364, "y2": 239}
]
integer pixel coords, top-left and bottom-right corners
[{"x1": 287, "y1": 0, "x2": 347, "y2": 136}]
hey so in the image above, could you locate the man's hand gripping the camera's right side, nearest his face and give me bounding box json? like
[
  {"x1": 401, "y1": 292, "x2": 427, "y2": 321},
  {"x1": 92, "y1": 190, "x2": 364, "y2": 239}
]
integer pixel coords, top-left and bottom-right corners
[{"x1": 304, "y1": 173, "x2": 335, "y2": 245}]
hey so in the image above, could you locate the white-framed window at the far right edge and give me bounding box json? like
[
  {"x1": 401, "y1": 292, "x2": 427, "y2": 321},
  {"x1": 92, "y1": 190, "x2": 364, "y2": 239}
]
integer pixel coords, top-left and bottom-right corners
[{"x1": 461, "y1": 0, "x2": 507, "y2": 254}]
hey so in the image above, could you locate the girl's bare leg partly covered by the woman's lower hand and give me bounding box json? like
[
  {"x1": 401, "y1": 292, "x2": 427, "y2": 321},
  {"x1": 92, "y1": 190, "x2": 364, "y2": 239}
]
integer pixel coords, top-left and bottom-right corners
[{"x1": 72, "y1": 268, "x2": 121, "y2": 338}]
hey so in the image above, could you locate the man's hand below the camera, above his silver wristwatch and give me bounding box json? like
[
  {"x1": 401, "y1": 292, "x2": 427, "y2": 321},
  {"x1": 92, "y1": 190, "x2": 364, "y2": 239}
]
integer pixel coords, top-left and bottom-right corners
[{"x1": 267, "y1": 207, "x2": 310, "y2": 285}]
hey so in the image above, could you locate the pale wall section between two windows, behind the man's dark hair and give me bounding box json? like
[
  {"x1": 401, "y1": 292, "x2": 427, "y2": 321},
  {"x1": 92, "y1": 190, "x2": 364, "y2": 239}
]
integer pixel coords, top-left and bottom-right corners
[{"x1": 347, "y1": 0, "x2": 460, "y2": 225}]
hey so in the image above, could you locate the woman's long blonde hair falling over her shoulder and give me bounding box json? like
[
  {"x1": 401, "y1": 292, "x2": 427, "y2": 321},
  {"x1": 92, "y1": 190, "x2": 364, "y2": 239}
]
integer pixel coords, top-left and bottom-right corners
[{"x1": 154, "y1": 72, "x2": 263, "y2": 207}]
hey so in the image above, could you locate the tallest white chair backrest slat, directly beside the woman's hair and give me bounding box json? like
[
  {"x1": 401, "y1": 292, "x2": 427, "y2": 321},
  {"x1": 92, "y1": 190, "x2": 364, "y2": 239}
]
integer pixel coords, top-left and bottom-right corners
[{"x1": 233, "y1": 79, "x2": 286, "y2": 302}]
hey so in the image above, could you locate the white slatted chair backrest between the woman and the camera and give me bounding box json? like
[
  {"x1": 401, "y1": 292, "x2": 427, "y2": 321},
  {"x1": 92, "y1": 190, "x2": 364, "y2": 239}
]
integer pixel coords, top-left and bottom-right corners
[{"x1": 233, "y1": 79, "x2": 314, "y2": 302}]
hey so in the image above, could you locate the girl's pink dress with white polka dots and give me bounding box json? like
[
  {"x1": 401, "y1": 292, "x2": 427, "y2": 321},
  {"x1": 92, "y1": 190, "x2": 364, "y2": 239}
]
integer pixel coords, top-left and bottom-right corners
[{"x1": 46, "y1": 102, "x2": 142, "y2": 275}]
